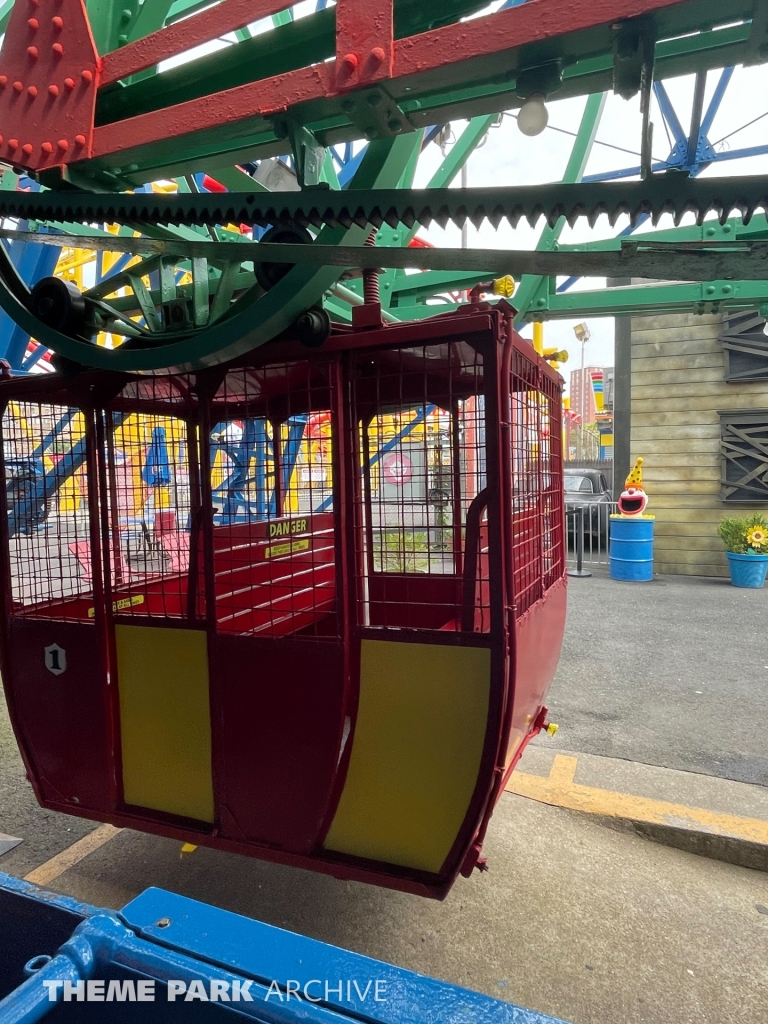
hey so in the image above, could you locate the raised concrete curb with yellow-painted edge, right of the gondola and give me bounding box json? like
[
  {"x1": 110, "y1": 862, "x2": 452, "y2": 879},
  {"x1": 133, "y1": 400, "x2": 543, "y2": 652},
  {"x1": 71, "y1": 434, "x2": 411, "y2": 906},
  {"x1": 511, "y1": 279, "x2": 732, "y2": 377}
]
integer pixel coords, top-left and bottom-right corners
[{"x1": 507, "y1": 749, "x2": 768, "y2": 871}]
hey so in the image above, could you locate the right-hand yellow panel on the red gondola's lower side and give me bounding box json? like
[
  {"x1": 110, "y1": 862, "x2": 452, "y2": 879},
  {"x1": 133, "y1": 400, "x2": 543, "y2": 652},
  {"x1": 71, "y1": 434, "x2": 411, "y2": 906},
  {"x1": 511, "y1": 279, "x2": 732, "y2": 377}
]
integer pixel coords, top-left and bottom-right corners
[{"x1": 325, "y1": 640, "x2": 490, "y2": 871}]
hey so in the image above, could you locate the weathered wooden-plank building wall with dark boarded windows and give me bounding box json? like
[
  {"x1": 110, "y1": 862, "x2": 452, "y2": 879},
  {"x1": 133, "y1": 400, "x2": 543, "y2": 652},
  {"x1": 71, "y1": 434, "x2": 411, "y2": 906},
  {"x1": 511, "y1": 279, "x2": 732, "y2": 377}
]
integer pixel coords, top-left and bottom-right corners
[{"x1": 630, "y1": 313, "x2": 768, "y2": 575}]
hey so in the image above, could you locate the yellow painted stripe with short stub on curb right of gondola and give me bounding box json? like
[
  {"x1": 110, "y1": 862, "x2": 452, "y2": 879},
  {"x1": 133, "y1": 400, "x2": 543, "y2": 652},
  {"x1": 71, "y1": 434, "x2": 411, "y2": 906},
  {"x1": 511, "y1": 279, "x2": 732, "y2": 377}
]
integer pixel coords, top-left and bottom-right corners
[{"x1": 506, "y1": 754, "x2": 768, "y2": 845}]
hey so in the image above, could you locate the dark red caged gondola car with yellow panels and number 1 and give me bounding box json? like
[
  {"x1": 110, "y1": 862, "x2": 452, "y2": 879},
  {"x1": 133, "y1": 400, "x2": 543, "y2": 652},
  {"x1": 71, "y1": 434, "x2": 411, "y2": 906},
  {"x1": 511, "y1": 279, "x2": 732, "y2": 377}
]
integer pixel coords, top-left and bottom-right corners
[{"x1": 0, "y1": 303, "x2": 565, "y2": 897}]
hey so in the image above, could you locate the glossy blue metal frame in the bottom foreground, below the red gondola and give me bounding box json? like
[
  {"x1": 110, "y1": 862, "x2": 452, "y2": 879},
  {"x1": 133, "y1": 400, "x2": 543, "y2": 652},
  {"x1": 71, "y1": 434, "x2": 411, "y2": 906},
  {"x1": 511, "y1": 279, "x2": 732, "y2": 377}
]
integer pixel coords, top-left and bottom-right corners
[{"x1": 0, "y1": 872, "x2": 563, "y2": 1024}]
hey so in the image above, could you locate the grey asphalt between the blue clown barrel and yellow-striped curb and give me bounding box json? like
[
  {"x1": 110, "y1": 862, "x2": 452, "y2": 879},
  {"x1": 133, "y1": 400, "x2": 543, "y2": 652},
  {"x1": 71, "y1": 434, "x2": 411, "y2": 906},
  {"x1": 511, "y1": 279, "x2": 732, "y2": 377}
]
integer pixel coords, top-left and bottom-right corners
[{"x1": 536, "y1": 571, "x2": 768, "y2": 785}]
